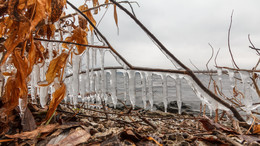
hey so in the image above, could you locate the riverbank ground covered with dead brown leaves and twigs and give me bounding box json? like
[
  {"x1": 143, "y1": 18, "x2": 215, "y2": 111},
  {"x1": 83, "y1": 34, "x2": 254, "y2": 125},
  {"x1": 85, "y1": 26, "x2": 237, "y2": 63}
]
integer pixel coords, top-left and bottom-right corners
[{"x1": 0, "y1": 101, "x2": 260, "y2": 146}]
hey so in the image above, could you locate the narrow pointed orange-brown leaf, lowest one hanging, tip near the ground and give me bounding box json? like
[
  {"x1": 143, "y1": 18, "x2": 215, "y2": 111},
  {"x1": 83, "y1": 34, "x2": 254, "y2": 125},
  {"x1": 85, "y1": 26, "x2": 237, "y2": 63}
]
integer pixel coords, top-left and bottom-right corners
[{"x1": 45, "y1": 83, "x2": 66, "y2": 121}]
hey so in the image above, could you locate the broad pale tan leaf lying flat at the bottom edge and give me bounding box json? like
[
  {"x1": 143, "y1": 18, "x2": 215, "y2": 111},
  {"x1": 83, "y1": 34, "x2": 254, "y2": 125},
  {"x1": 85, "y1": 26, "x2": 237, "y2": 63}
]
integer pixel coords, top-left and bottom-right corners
[{"x1": 57, "y1": 128, "x2": 91, "y2": 146}]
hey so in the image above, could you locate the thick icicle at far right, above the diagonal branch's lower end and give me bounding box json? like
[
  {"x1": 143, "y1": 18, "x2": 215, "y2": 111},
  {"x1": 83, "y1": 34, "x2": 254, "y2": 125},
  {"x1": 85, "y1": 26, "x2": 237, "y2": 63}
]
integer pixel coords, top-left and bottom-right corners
[{"x1": 239, "y1": 71, "x2": 253, "y2": 114}]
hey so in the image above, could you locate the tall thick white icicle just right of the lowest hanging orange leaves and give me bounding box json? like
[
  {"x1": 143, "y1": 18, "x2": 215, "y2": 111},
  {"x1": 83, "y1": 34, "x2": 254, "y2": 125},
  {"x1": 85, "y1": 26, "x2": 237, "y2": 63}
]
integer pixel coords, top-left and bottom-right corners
[{"x1": 72, "y1": 54, "x2": 81, "y2": 105}]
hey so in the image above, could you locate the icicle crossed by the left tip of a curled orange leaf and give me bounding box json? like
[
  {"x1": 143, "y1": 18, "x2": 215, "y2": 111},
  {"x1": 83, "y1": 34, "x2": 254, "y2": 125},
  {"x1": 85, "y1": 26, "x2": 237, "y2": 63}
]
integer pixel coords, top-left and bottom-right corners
[{"x1": 40, "y1": 63, "x2": 48, "y2": 108}]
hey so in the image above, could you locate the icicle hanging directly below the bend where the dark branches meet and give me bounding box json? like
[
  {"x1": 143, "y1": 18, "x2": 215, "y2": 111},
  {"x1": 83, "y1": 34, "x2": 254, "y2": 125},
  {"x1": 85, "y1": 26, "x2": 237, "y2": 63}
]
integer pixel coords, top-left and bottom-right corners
[{"x1": 127, "y1": 70, "x2": 135, "y2": 108}]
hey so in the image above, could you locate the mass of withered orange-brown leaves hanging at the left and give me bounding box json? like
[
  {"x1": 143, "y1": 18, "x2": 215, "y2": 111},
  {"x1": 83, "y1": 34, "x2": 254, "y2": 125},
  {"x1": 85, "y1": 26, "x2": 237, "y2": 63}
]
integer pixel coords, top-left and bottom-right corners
[{"x1": 0, "y1": 0, "x2": 118, "y2": 128}]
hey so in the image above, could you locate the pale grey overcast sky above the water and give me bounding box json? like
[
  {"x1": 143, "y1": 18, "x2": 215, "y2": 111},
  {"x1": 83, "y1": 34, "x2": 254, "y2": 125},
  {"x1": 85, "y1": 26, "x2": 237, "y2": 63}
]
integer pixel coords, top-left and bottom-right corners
[{"x1": 69, "y1": 0, "x2": 260, "y2": 69}]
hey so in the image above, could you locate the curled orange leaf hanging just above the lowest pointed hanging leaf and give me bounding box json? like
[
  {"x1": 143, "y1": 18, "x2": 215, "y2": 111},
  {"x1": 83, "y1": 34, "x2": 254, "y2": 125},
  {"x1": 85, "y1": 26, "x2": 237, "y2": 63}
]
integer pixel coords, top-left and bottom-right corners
[{"x1": 44, "y1": 53, "x2": 68, "y2": 86}]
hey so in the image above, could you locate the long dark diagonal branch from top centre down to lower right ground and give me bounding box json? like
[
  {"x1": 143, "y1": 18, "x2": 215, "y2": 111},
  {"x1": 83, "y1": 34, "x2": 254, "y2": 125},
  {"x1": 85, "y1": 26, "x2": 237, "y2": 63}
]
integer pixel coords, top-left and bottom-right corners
[{"x1": 110, "y1": 0, "x2": 245, "y2": 122}]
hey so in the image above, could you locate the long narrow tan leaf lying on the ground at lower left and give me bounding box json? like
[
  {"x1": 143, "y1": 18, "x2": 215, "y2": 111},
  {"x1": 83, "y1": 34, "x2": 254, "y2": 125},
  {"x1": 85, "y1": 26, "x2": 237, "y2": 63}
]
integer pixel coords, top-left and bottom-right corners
[{"x1": 5, "y1": 124, "x2": 58, "y2": 139}]
